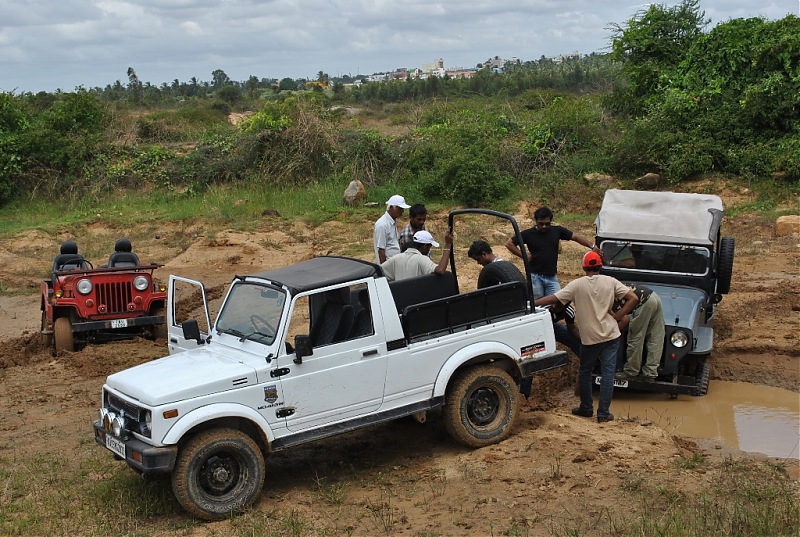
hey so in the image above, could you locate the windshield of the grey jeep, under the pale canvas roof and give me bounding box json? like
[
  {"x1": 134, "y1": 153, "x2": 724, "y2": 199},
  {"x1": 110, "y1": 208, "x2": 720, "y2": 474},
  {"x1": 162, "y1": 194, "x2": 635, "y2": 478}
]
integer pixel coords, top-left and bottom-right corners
[{"x1": 600, "y1": 240, "x2": 711, "y2": 276}]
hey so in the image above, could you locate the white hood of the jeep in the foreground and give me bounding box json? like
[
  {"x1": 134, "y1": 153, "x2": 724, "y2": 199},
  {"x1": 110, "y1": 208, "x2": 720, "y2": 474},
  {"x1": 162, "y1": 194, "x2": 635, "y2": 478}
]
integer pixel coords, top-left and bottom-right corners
[{"x1": 106, "y1": 348, "x2": 258, "y2": 406}]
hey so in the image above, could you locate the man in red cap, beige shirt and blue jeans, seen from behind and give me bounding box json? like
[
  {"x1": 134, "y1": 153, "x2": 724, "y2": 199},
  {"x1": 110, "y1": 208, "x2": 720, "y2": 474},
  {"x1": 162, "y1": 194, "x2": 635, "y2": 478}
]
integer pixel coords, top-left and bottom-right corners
[{"x1": 534, "y1": 251, "x2": 639, "y2": 423}]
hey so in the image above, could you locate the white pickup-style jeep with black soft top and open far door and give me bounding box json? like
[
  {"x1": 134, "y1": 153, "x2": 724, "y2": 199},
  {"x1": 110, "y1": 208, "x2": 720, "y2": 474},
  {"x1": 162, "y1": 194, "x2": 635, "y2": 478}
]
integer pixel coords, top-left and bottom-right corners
[{"x1": 94, "y1": 209, "x2": 567, "y2": 520}]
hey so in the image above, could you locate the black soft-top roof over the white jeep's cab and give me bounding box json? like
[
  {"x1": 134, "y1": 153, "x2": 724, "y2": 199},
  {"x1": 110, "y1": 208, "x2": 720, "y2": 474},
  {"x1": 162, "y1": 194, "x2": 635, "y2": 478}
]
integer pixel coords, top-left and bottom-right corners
[{"x1": 252, "y1": 256, "x2": 383, "y2": 293}]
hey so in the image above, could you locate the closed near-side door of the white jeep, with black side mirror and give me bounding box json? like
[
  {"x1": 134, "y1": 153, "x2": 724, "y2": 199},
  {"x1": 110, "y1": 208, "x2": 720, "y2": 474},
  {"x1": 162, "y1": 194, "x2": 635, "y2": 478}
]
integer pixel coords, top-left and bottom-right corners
[{"x1": 278, "y1": 281, "x2": 387, "y2": 432}]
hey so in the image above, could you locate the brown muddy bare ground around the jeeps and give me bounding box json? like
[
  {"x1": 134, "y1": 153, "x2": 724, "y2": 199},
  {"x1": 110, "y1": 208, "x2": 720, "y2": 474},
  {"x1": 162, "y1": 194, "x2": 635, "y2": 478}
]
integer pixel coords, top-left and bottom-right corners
[{"x1": 0, "y1": 185, "x2": 800, "y2": 535}]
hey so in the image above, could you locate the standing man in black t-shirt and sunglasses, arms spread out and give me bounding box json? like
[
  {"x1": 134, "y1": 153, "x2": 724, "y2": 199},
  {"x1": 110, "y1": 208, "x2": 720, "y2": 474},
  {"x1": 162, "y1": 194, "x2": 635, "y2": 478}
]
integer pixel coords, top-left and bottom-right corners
[{"x1": 506, "y1": 207, "x2": 600, "y2": 298}]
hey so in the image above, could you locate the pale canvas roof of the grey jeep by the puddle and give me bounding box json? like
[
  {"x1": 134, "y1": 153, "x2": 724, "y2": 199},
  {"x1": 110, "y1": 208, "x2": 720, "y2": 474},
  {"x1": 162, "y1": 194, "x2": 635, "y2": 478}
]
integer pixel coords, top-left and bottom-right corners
[{"x1": 594, "y1": 189, "x2": 722, "y2": 246}]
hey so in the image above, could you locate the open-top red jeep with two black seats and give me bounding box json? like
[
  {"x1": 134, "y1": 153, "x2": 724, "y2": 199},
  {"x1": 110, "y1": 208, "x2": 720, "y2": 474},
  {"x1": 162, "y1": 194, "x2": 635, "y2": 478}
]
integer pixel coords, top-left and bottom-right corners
[{"x1": 39, "y1": 239, "x2": 167, "y2": 353}]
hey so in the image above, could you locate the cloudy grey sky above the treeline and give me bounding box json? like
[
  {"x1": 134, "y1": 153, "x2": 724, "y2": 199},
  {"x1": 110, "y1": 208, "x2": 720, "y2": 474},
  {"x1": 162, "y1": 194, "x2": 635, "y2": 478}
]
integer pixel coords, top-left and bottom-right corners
[{"x1": 0, "y1": 0, "x2": 800, "y2": 94}]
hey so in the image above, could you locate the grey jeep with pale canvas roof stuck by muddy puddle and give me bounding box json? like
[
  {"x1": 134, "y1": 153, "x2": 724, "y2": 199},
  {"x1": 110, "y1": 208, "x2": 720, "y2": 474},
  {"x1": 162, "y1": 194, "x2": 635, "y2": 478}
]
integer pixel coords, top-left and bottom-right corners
[{"x1": 595, "y1": 189, "x2": 734, "y2": 396}]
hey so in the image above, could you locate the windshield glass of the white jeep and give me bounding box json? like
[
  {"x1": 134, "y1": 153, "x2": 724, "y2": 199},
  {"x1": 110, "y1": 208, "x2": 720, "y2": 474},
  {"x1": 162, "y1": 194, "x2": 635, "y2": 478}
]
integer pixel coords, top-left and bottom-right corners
[{"x1": 216, "y1": 281, "x2": 286, "y2": 345}]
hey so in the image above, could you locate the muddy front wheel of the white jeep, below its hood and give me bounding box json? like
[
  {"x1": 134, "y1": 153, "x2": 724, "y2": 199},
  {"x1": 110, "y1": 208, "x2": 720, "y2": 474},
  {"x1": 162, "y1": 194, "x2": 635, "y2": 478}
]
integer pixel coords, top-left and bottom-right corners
[{"x1": 172, "y1": 429, "x2": 265, "y2": 520}]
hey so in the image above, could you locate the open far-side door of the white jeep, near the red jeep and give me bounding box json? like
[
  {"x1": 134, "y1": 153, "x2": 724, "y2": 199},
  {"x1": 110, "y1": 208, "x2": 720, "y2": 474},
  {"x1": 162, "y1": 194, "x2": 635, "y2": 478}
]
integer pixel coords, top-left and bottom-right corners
[{"x1": 167, "y1": 274, "x2": 211, "y2": 354}]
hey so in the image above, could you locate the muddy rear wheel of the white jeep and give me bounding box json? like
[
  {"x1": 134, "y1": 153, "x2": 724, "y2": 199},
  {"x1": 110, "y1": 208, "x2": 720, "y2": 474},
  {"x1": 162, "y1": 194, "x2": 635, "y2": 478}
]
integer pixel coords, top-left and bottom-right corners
[{"x1": 443, "y1": 366, "x2": 518, "y2": 447}]
